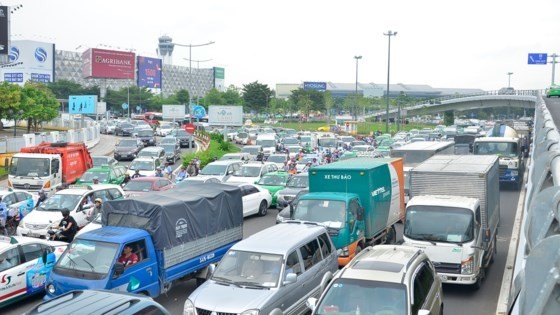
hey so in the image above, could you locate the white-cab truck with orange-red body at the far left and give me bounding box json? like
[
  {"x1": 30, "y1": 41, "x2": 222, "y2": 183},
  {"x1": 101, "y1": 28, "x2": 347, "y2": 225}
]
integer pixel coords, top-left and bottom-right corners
[{"x1": 8, "y1": 142, "x2": 93, "y2": 194}]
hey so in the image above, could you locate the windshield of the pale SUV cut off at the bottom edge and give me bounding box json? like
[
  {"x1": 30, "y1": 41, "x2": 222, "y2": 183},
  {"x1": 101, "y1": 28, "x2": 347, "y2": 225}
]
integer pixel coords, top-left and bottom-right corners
[{"x1": 315, "y1": 278, "x2": 409, "y2": 315}]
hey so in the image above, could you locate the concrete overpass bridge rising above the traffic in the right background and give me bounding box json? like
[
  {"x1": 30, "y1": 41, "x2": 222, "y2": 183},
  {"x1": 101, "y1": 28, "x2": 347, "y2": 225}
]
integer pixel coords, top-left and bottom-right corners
[{"x1": 366, "y1": 90, "x2": 541, "y2": 119}]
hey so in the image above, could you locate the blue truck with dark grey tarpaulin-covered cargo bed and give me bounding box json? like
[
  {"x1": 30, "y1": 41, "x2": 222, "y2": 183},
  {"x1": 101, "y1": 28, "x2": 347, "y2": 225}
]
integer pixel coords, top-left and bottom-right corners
[{"x1": 45, "y1": 184, "x2": 243, "y2": 300}]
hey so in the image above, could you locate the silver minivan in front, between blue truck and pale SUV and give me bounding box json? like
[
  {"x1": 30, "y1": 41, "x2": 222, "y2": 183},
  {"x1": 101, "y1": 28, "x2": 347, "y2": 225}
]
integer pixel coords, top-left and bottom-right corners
[{"x1": 183, "y1": 222, "x2": 338, "y2": 314}]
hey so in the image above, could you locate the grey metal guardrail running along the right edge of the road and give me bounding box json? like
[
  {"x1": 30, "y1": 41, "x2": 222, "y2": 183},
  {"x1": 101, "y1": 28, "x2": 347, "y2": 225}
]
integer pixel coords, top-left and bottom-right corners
[{"x1": 496, "y1": 93, "x2": 560, "y2": 315}]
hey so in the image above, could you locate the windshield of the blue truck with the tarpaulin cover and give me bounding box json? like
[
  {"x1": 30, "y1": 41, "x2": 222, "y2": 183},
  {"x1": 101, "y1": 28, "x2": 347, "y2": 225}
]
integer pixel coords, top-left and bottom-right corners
[{"x1": 55, "y1": 239, "x2": 119, "y2": 279}]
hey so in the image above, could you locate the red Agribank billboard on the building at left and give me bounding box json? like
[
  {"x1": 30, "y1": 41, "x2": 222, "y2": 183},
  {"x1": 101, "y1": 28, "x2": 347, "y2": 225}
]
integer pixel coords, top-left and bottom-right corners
[{"x1": 82, "y1": 48, "x2": 136, "y2": 79}]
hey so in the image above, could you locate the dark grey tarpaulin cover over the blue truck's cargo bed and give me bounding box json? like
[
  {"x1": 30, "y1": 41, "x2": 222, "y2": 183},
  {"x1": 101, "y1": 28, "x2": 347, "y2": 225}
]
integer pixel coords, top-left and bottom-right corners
[{"x1": 101, "y1": 184, "x2": 243, "y2": 250}]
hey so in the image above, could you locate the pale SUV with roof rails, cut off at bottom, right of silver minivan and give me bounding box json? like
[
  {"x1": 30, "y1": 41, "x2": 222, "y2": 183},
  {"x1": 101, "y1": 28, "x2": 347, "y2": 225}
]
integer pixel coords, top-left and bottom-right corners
[{"x1": 307, "y1": 245, "x2": 443, "y2": 315}]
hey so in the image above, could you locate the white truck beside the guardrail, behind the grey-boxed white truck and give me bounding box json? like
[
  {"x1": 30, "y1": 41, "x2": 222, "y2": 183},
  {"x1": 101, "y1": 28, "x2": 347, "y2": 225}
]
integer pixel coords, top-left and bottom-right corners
[{"x1": 473, "y1": 124, "x2": 527, "y2": 190}]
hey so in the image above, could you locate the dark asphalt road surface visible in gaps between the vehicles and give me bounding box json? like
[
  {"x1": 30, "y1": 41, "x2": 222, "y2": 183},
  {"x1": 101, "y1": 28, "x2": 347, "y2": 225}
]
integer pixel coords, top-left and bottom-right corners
[{"x1": 0, "y1": 134, "x2": 519, "y2": 315}]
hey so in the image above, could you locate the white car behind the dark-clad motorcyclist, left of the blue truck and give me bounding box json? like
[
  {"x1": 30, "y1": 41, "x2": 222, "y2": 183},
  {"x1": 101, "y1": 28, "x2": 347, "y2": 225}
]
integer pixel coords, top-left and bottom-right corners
[{"x1": 17, "y1": 184, "x2": 124, "y2": 238}]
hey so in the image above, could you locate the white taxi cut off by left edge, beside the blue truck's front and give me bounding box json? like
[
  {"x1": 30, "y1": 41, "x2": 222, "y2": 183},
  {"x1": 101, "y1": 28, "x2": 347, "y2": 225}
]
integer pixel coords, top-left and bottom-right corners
[{"x1": 0, "y1": 236, "x2": 68, "y2": 308}]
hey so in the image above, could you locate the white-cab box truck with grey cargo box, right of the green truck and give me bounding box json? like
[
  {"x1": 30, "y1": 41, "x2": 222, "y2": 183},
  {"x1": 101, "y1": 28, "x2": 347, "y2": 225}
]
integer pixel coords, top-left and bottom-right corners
[{"x1": 403, "y1": 155, "x2": 500, "y2": 289}]
